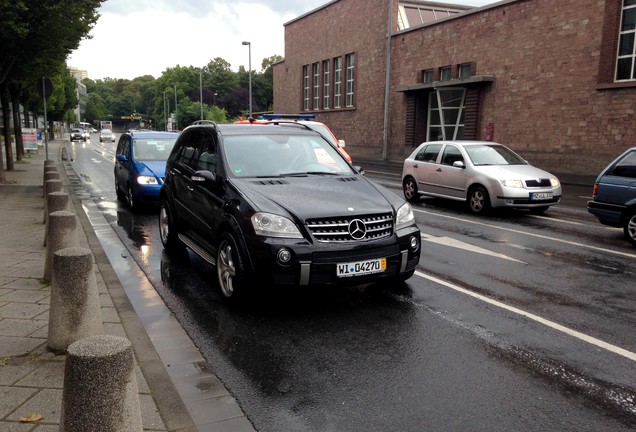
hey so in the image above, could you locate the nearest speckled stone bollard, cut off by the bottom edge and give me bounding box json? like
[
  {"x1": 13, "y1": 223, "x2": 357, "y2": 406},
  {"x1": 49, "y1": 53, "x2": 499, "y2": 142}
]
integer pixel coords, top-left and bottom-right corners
[{"x1": 60, "y1": 335, "x2": 143, "y2": 432}]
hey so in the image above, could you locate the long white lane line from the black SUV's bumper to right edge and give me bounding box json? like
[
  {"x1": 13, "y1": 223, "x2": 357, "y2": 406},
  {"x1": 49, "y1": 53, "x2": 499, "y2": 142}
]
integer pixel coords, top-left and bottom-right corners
[{"x1": 415, "y1": 271, "x2": 636, "y2": 361}]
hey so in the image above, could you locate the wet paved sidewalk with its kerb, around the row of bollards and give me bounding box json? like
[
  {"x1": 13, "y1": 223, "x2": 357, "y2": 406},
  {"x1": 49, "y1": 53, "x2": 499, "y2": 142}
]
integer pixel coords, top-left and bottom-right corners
[{"x1": 0, "y1": 141, "x2": 254, "y2": 432}]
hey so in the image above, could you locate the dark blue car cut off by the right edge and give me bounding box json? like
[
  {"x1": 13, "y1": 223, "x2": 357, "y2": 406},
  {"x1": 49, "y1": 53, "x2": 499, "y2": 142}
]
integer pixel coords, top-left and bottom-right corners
[{"x1": 587, "y1": 147, "x2": 636, "y2": 246}]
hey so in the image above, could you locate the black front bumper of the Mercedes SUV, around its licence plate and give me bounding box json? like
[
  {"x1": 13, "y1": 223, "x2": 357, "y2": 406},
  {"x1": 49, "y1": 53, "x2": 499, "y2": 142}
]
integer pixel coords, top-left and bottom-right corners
[{"x1": 243, "y1": 227, "x2": 421, "y2": 286}]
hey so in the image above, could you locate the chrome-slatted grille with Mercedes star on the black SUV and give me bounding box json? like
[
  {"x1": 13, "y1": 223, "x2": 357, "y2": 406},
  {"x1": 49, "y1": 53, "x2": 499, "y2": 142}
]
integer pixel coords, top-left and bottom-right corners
[{"x1": 307, "y1": 213, "x2": 393, "y2": 242}]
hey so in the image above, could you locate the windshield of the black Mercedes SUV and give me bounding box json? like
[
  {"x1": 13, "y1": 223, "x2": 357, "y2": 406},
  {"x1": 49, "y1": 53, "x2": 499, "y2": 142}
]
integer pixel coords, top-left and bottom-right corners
[{"x1": 223, "y1": 134, "x2": 353, "y2": 177}]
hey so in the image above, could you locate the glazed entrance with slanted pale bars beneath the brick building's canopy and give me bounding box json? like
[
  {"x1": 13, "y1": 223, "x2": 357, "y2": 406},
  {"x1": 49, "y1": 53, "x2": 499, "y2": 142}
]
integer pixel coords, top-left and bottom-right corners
[{"x1": 426, "y1": 88, "x2": 466, "y2": 141}]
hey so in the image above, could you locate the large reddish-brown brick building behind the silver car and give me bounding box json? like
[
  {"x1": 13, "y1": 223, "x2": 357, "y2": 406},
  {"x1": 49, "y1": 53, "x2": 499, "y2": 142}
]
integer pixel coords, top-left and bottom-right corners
[{"x1": 274, "y1": 0, "x2": 636, "y2": 174}]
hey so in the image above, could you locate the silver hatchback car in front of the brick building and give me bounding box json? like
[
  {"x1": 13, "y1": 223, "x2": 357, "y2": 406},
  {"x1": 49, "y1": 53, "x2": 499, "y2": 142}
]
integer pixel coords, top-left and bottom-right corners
[{"x1": 402, "y1": 141, "x2": 562, "y2": 214}]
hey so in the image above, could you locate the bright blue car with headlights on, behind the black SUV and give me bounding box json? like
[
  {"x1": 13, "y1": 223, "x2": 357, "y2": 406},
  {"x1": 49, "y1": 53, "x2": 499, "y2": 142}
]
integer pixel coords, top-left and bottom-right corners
[{"x1": 115, "y1": 131, "x2": 179, "y2": 210}]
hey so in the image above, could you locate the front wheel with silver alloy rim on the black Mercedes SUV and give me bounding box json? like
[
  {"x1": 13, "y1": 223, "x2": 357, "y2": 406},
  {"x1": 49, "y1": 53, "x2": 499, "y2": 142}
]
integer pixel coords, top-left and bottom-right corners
[{"x1": 216, "y1": 232, "x2": 245, "y2": 300}]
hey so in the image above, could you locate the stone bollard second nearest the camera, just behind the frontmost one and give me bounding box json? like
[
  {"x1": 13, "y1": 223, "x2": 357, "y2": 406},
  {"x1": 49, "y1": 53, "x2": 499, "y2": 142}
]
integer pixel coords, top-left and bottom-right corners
[{"x1": 46, "y1": 247, "x2": 104, "y2": 354}]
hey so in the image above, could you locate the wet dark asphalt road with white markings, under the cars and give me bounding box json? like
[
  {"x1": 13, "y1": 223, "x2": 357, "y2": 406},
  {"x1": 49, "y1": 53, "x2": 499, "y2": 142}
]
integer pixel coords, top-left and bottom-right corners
[{"x1": 68, "y1": 136, "x2": 636, "y2": 431}]
